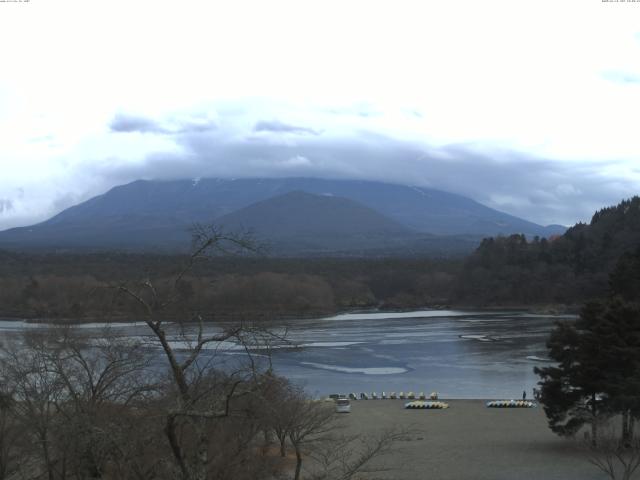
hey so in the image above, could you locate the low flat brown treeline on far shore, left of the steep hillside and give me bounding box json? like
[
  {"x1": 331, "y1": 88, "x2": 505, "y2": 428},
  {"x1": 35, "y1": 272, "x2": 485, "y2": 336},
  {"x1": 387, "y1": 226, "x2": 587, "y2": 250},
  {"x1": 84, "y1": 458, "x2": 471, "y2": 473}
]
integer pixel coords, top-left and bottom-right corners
[{"x1": 0, "y1": 252, "x2": 460, "y2": 320}]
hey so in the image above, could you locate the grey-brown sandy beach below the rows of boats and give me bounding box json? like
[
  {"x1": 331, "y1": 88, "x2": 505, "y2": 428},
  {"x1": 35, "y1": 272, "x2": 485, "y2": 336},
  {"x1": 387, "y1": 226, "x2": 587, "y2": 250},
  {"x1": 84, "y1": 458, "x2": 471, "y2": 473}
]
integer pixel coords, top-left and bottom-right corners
[{"x1": 340, "y1": 400, "x2": 605, "y2": 480}]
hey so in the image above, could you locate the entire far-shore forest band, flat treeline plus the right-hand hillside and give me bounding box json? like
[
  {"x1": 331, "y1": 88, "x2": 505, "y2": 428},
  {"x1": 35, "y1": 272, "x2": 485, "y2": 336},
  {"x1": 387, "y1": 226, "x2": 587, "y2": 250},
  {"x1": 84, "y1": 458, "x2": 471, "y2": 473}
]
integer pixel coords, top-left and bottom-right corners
[{"x1": 0, "y1": 197, "x2": 640, "y2": 319}]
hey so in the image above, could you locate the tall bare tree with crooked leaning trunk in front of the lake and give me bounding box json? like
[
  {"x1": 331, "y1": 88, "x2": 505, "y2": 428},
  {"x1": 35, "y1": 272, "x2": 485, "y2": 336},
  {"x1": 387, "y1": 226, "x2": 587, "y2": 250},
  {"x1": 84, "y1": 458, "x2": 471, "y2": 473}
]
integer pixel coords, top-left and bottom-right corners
[{"x1": 115, "y1": 226, "x2": 272, "y2": 480}]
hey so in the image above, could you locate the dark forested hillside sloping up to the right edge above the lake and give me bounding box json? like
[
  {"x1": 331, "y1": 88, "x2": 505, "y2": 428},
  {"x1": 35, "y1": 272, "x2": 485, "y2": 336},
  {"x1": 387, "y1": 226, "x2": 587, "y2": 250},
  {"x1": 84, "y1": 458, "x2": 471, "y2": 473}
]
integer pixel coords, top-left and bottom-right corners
[{"x1": 454, "y1": 197, "x2": 640, "y2": 305}]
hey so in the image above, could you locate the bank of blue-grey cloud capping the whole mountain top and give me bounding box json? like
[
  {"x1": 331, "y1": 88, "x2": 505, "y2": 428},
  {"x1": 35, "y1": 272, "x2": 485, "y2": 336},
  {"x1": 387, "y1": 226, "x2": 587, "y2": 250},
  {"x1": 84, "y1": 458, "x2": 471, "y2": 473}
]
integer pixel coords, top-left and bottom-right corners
[{"x1": 0, "y1": 101, "x2": 638, "y2": 228}]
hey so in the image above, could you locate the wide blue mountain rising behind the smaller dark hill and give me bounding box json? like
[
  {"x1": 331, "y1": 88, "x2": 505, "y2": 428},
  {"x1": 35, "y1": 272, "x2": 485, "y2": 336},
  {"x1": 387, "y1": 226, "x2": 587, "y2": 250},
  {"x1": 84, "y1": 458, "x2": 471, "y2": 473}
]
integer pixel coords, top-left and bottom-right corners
[{"x1": 0, "y1": 178, "x2": 563, "y2": 249}]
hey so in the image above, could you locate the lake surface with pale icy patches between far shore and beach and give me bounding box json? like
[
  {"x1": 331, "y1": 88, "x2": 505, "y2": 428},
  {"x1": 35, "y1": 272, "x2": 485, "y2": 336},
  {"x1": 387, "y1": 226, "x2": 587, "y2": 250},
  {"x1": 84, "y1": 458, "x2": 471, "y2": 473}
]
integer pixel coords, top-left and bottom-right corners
[{"x1": 0, "y1": 310, "x2": 572, "y2": 398}]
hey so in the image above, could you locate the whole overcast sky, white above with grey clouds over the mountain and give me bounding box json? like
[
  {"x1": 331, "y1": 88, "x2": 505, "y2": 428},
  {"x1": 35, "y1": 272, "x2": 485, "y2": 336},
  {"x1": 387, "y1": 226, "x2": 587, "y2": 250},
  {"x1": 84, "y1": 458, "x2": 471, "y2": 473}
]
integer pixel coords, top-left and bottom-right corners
[{"x1": 0, "y1": 0, "x2": 640, "y2": 229}]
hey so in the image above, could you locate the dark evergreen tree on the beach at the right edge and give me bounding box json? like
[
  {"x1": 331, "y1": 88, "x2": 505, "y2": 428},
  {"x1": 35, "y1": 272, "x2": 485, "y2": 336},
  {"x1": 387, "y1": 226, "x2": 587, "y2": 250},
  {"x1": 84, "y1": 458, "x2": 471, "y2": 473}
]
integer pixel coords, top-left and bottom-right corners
[{"x1": 535, "y1": 284, "x2": 640, "y2": 442}]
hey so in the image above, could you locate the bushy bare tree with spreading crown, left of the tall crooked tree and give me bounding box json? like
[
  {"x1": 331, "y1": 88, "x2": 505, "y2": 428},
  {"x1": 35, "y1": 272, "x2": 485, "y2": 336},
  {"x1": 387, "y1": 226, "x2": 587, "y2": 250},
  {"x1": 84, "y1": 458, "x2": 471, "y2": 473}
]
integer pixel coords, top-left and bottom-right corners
[{"x1": 47, "y1": 327, "x2": 157, "y2": 478}]
